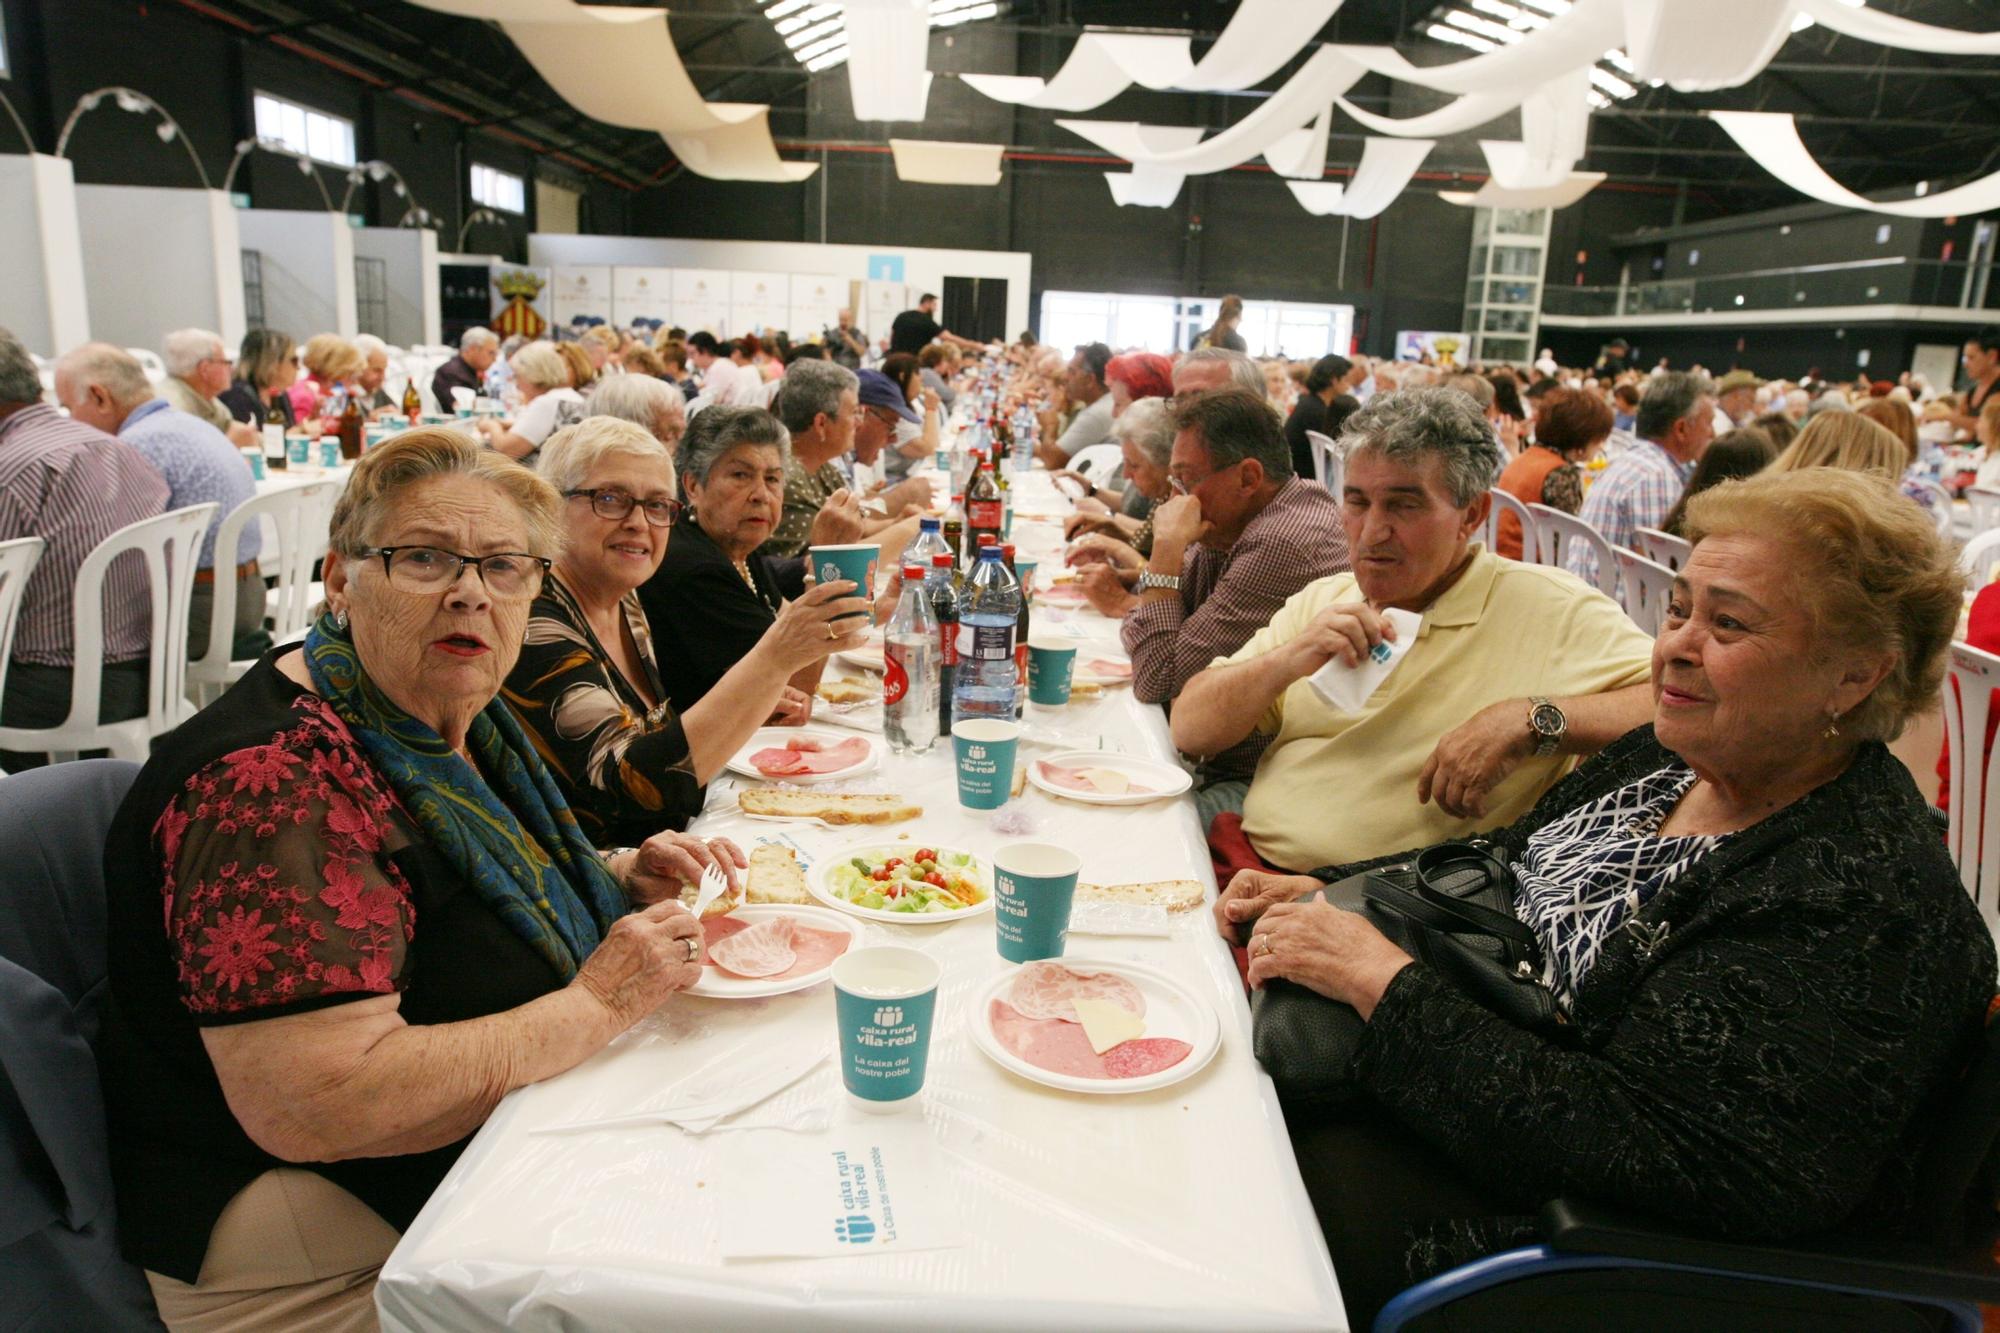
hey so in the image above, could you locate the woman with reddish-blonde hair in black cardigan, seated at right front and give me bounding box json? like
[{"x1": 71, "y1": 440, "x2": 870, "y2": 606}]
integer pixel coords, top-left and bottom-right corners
[{"x1": 1216, "y1": 468, "x2": 1994, "y2": 1327}]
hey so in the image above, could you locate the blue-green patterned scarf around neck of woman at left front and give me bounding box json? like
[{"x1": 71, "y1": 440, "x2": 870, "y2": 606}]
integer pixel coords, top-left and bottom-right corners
[{"x1": 306, "y1": 614, "x2": 630, "y2": 981}]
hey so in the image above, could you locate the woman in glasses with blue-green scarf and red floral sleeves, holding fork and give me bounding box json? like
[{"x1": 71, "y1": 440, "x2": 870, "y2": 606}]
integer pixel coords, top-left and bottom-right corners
[{"x1": 100, "y1": 426, "x2": 742, "y2": 1329}]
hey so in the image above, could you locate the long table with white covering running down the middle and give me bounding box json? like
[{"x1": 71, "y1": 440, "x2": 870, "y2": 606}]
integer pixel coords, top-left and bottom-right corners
[{"x1": 376, "y1": 474, "x2": 1346, "y2": 1331}]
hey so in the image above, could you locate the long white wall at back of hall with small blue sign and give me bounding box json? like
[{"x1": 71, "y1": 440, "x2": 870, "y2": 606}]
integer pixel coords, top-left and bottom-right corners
[{"x1": 528, "y1": 232, "x2": 1032, "y2": 348}]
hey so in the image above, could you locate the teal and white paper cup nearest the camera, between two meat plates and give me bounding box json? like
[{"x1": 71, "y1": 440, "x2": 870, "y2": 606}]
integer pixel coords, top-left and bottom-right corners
[{"x1": 832, "y1": 945, "x2": 942, "y2": 1111}]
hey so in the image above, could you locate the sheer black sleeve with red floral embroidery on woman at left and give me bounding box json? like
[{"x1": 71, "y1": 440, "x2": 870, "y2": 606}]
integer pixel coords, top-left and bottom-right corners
[{"x1": 154, "y1": 695, "x2": 416, "y2": 1015}]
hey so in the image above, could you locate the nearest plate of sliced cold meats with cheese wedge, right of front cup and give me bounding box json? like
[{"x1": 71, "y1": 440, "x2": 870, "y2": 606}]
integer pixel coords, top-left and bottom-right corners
[{"x1": 968, "y1": 957, "x2": 1222, "y2": 1095}]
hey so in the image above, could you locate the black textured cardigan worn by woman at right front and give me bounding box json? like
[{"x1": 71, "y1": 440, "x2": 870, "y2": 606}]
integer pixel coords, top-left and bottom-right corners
[{"x1": 1318, "y1": 727, "x2": 1994, "y2": 1237}]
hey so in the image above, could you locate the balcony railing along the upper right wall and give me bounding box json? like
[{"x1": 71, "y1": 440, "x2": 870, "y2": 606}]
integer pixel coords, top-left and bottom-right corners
[{"x1": 1542, "y1": 258, "x2": 2000, "y2": 318}]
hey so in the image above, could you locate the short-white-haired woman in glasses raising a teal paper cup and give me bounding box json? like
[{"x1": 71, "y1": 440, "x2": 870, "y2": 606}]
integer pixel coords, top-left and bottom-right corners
[{"x1": 500, "y1": 416, "x2": 866, "y2": 847}]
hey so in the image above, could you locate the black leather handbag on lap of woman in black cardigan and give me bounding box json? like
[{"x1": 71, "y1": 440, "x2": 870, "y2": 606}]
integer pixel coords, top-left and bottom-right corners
[{"x1": 1250, "y1": 843, "x2": 1566, "y2": 1109}]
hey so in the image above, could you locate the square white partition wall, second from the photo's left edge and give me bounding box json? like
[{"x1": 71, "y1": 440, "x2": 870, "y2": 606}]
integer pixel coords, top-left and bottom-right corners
[{"x1": 76, "y1": 186, "x2": 244, "y2": 352}]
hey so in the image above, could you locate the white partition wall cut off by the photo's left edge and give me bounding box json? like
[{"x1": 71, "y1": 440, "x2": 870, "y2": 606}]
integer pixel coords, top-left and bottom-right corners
[{"x1": 0, "y1": 154, "x2": 90, "y2": 356}]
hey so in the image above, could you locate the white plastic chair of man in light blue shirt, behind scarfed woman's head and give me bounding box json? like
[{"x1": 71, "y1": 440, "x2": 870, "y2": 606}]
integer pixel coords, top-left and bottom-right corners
[{"x1": 188, "y1": 480, "x2": 340, "y2": 707}]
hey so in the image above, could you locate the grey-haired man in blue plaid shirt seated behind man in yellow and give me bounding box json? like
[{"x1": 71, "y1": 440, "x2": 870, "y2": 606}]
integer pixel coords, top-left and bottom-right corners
[{"x1": 1562, "y1": 370, "x2": 1716, "y2": 582}]
